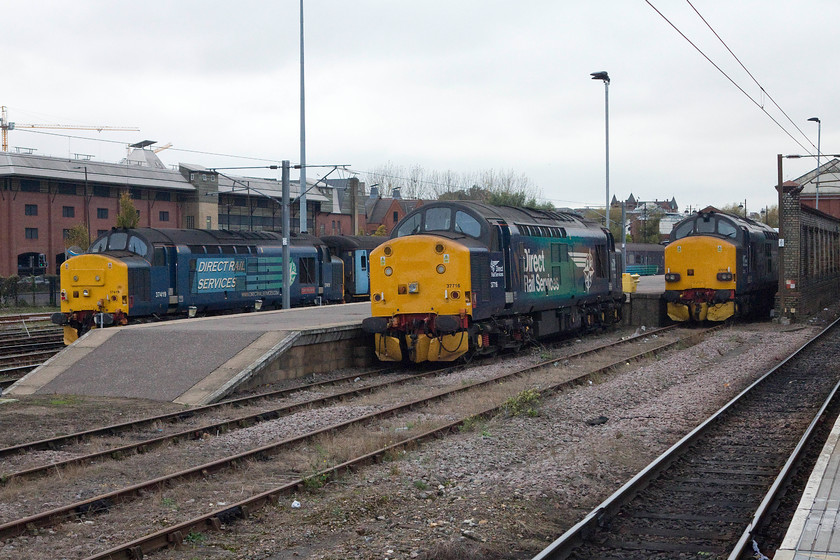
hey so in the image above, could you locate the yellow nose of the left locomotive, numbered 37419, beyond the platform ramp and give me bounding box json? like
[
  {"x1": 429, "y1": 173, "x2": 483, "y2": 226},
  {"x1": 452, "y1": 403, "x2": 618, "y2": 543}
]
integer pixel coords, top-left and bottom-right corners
[{"x1": 61, "y1": 254, "x2": 129, "y2": 344}]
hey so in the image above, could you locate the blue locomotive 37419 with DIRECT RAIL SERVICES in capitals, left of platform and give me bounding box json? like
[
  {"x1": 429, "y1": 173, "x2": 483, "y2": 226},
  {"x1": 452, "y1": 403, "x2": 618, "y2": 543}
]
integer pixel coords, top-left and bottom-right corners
[{"x1": 52, "y1": 228, "x2": 380, "y2": 344}]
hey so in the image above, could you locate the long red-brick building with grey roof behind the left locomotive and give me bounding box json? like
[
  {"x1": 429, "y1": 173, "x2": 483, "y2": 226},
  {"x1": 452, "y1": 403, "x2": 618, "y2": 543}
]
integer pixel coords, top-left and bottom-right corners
[{"x1": 0, "y1": 148, "x2": 365, "y2": 276}]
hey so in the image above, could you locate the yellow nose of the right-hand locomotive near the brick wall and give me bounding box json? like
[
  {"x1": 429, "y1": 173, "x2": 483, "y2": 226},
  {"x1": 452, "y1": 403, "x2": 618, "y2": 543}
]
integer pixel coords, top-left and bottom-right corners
[{"x1": 665, "y1": 236, "x2": 737, "y2": 322}]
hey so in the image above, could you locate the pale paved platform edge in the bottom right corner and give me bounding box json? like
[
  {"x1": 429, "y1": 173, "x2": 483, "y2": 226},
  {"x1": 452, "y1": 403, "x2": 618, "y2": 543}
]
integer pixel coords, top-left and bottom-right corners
[{"x1": 773, "y1": 410, "x2": 840, "y2": 560}]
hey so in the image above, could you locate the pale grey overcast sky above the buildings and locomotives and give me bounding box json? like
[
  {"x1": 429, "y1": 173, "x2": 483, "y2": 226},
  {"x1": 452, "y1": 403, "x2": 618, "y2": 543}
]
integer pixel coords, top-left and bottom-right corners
[{"x1": 0, "y1": 0, "x2": 840, "y2": 210}]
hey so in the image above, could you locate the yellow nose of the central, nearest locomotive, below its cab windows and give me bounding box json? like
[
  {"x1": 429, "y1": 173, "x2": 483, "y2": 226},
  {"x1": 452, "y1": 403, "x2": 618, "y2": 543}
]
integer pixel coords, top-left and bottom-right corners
[{"x1": 366, "y1": 235, "x2": 472, "y2": 362}]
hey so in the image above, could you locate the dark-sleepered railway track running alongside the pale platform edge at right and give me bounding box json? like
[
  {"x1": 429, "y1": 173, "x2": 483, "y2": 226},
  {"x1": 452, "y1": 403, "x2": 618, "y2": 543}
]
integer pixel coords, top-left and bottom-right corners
[{"x1": 534, "y1": 322, "x2": 840, "y2": 560}]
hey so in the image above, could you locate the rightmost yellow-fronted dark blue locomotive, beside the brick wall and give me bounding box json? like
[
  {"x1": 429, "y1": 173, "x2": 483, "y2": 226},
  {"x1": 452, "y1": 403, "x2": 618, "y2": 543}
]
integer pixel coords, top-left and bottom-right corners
[{"x1": 665, "y1": 206, "x2": 779, "y2": 321}]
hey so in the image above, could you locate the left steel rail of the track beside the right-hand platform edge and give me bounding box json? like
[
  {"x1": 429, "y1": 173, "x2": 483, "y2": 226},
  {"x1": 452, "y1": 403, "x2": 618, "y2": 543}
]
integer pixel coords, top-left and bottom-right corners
[{"x1": 532, "y1": 319, "x2": 840, "y2": 560}]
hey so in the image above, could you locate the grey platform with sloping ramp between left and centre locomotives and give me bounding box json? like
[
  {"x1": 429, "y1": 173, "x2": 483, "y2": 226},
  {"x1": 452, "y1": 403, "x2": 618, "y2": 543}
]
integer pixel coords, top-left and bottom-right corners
[{"x1": 3, "y1": 302, "x2": 373, "y2": 405}]
